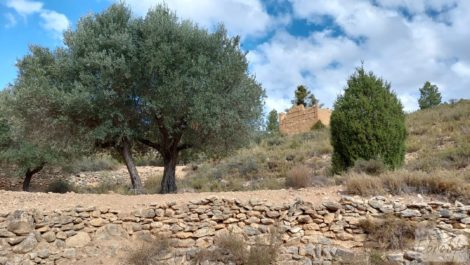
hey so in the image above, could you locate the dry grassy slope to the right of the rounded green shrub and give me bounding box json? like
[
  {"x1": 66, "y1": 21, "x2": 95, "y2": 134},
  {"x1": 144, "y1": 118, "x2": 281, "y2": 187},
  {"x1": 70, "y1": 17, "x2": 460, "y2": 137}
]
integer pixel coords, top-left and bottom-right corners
[{"x1": 406, "y1": 100, "x2": 470, "y2": 172}]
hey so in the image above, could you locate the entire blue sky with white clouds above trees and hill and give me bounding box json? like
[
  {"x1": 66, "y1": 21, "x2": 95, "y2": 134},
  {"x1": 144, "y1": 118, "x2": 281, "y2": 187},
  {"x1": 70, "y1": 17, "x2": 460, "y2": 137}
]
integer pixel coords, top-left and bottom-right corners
[{"x1": 0, "y1": 0, "x2": 470, "y2": 111}]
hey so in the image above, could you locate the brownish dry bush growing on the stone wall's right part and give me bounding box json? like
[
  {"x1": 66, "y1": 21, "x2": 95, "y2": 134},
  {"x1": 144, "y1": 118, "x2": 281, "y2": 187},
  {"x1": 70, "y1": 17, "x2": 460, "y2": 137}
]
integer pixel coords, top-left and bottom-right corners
[{"x1": 359, "y1": 215, "x2": 417, "y2": 249}]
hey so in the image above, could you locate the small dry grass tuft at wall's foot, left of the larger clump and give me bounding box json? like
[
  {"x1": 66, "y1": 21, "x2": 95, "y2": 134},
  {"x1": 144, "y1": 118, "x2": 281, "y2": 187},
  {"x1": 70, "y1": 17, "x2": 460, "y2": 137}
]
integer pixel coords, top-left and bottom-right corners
[{"x1": 127, "y1": 237, "x2": 171, "y2": 265}]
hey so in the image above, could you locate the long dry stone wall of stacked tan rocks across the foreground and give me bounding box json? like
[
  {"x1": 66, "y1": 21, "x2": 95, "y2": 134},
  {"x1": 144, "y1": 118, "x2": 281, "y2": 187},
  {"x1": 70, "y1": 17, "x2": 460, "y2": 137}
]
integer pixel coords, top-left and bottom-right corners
[{"x1": 0, "y1": 196, "x2": 470, "y2": 265}]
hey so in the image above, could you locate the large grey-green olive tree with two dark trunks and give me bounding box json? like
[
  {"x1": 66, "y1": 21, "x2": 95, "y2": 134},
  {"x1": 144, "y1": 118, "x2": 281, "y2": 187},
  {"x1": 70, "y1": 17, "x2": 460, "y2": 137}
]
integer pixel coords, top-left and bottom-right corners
[{"x1": 8, "y1": 4, "x2": 264, "y2": 193}]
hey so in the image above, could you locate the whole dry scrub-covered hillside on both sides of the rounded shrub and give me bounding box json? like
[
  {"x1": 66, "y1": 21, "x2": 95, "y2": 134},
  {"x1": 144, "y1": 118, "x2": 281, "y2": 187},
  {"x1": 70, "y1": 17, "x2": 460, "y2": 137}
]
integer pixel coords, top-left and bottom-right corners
[{"x1": 180, "y1": 100, "x2": 470, "y2": 195}]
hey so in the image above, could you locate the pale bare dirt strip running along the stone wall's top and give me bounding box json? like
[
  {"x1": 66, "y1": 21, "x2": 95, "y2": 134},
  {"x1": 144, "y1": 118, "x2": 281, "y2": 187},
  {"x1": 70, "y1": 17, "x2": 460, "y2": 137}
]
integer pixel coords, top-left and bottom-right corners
[{"x1": 0, "y1": 186, "x2": 341, "y2": 213}]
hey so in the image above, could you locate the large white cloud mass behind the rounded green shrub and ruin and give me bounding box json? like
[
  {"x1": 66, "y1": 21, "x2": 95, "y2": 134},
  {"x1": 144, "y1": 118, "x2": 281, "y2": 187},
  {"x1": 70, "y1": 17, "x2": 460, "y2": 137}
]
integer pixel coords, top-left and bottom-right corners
[{"x1": 249, "y1": 0, "x2": 470, "y2": 111}]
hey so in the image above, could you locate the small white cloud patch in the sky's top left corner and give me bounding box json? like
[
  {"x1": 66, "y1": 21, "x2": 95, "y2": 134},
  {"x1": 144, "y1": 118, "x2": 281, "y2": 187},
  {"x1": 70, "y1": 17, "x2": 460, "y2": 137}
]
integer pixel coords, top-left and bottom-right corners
[{"x1": 6, "y1": 0, "x2": 70, "y2": 38}]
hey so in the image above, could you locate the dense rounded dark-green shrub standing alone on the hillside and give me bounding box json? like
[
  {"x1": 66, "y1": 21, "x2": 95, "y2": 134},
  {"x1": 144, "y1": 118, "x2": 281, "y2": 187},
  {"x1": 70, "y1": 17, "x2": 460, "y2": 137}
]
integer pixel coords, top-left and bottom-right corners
[{"x1": 330, "y1": 67, "x2": 406, "y2": 173}]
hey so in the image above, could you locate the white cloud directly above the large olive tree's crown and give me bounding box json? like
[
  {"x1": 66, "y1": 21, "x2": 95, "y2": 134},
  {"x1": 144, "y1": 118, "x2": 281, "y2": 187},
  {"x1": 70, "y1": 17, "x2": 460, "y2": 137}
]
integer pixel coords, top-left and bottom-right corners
[{"x1": 118, "y1": 0, "x2": 275, "y2": 36}]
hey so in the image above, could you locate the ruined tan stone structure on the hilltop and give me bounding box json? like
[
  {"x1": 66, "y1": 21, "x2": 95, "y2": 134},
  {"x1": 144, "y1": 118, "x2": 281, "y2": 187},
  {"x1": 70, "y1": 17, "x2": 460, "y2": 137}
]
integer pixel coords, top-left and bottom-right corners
[{"x1": 279, "y1": 105, "x2": 331, "y2": 135}]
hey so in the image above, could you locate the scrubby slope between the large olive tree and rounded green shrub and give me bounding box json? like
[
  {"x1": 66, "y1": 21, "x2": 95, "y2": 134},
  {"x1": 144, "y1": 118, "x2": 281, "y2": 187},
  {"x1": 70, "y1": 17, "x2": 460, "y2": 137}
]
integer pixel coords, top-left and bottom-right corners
[{"x1": 180, "y1": 128, "x2": 332, "y2": 191}]
